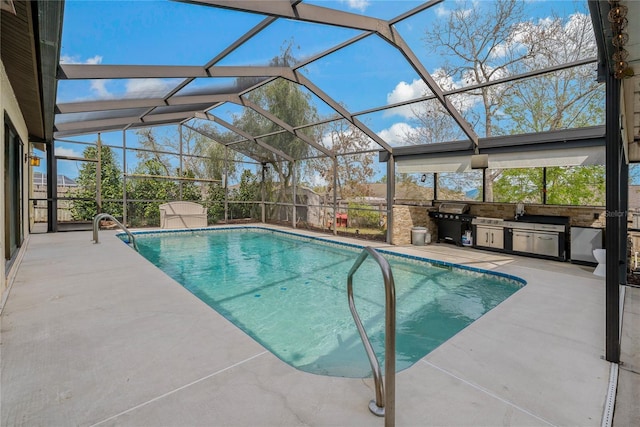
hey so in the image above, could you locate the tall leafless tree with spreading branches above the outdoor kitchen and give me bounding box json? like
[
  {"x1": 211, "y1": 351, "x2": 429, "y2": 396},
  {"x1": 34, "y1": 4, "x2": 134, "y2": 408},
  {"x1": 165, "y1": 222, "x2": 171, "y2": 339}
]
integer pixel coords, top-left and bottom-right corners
[{"x1": 417, "y1": 0, "x2": 601, "y2": 201}]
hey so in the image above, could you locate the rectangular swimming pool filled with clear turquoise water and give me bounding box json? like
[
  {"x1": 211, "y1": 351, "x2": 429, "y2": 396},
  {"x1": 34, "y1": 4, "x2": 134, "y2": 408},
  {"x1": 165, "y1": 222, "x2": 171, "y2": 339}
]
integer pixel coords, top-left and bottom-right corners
[{"x1": 134, "y1": 227, "x2": 524, "y2": 378}]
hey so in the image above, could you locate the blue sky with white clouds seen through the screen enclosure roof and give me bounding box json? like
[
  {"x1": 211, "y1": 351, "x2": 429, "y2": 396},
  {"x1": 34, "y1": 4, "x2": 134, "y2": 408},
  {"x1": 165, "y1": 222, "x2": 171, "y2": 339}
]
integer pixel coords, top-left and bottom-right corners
[{"x1": 52, "y1": 0, "x2": 588, "y2": 182}]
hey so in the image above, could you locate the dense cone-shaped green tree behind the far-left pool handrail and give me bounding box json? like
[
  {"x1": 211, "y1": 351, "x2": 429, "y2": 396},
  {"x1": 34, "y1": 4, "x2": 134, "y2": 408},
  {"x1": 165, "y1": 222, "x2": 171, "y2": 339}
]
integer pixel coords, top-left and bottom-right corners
[{"x1": 71, "y1": 146, "x2": 122, "y2": 220}]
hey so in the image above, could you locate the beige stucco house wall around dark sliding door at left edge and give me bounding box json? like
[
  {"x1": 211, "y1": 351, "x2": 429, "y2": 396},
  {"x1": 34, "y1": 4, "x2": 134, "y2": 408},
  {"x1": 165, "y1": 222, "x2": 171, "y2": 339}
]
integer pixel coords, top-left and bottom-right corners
[{"x1": 0, "y1": 62, "x2": 29, "y2": 307}]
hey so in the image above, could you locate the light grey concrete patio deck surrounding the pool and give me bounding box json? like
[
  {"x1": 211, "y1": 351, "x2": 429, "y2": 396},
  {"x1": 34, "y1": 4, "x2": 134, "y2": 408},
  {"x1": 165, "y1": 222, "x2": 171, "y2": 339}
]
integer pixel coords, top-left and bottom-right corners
[{"x1": 0, "y1": 227, "x2": 640, "y2": 426}]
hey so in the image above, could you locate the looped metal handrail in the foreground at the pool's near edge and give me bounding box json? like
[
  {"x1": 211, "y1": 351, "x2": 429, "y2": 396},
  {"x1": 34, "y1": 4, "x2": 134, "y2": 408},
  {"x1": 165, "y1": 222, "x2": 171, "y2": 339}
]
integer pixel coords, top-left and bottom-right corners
[{"x1": 347, "y1": 247, "x2": 396, "y2": 427}]
